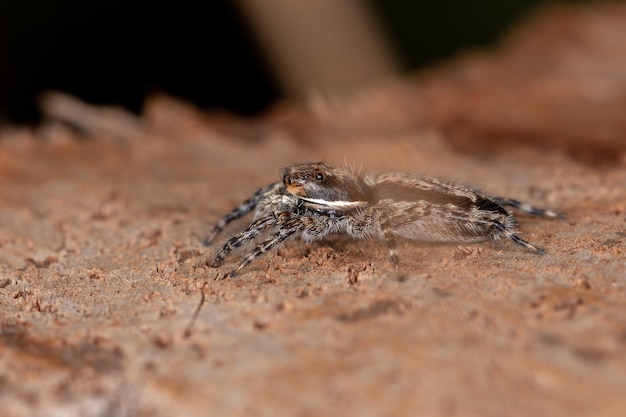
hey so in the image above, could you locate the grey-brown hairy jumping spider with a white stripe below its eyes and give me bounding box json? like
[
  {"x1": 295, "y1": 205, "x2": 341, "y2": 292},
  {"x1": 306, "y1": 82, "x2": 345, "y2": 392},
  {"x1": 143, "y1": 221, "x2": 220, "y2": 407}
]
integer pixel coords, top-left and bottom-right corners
[{"x1": 205, "y1": 162, "x2": 564, "y2": 276}]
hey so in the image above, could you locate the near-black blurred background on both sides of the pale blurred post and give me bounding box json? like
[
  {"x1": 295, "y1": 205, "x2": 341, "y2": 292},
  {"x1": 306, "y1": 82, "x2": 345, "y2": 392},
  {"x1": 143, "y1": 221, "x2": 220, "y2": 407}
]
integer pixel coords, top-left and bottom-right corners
[{"x1": 0, "y1": 0, "x2": 584, "y2": 123}]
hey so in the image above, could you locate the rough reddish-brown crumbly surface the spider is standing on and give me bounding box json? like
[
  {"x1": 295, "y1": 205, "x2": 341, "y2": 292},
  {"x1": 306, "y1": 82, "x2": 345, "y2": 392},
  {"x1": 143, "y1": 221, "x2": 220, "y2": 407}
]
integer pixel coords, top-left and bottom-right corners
[{"x1": 0, "y1": 5, "x2": 626, "y2": 416}]
